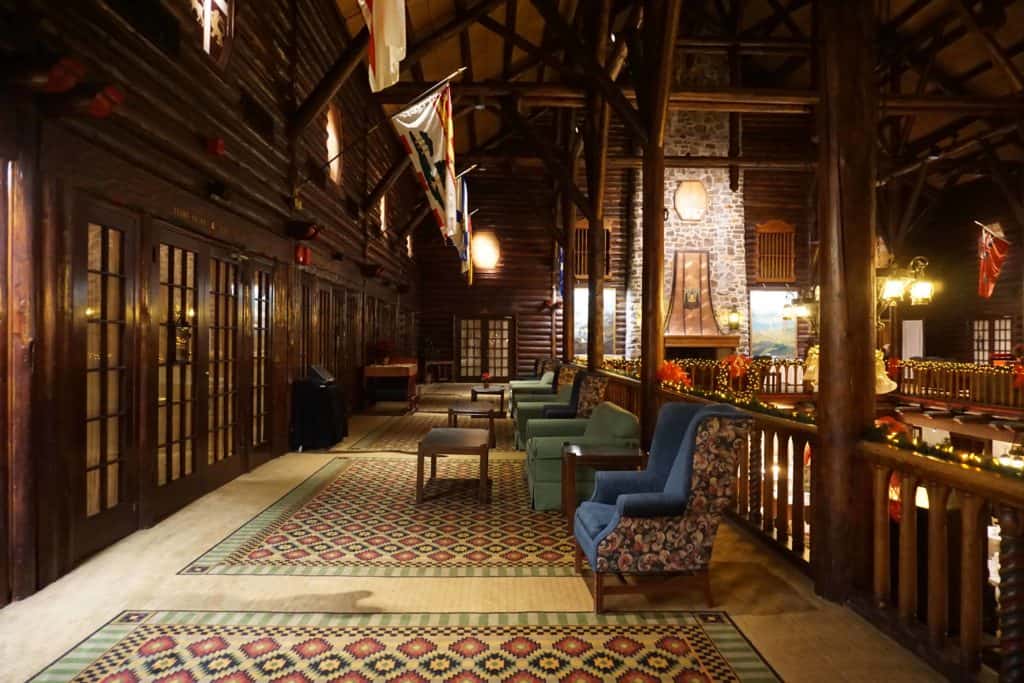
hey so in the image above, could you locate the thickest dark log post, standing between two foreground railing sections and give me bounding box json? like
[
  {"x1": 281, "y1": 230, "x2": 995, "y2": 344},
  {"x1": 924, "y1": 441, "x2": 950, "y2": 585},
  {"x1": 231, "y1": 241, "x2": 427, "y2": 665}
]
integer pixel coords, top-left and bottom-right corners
[{"x1": 811, "y1": 0, "x2": 876, "y2": 601}]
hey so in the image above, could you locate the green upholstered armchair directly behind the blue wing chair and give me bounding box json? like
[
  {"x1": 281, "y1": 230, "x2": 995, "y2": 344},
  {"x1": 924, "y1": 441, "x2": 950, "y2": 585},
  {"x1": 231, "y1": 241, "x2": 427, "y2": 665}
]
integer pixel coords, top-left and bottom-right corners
[{"x1": 526, "y1": 401, "x2": 640, "y2": 510}]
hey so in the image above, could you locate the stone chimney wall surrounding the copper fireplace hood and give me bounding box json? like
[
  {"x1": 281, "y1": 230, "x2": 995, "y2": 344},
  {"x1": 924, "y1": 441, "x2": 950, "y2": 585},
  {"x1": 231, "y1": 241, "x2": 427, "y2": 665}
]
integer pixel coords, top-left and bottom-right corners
[{"x1": 626, "y1": 55, "x2": 750, "y2": 357}]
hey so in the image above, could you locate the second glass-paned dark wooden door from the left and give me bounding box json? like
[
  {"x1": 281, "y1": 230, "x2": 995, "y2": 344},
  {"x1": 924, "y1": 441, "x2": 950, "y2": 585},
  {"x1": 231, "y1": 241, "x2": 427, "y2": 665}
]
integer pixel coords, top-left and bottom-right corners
[{"x1": 142, "y1": 221, "x2": 210, "y2": 521}]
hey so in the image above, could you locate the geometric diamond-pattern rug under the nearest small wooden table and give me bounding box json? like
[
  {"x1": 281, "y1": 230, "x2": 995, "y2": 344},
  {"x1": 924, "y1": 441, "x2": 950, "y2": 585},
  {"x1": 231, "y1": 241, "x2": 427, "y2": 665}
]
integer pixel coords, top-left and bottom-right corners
[{"x1": 180, "y1": 458, "x2": 573, "y2": 577}]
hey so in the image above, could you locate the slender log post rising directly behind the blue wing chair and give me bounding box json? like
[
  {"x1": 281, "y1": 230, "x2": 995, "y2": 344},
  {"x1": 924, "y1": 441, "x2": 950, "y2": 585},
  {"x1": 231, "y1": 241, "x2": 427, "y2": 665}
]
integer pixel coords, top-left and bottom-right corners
[{"x1": 640, "y1": 0, "x2": 681, "y2": 443}]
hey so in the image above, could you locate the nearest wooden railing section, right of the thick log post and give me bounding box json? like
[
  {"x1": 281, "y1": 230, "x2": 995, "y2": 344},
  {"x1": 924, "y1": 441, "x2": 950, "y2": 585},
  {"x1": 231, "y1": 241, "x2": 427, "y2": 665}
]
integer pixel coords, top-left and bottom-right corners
[{"x1": 855, "y1": 442, "x2": 1024, "y2": 680}]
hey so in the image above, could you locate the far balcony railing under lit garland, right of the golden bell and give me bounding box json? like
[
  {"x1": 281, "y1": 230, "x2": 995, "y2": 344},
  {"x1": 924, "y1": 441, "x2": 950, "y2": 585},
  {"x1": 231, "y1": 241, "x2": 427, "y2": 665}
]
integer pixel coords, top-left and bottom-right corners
[{"x1": 897, "y1": 360, "x2": 1024, "y2": 410}]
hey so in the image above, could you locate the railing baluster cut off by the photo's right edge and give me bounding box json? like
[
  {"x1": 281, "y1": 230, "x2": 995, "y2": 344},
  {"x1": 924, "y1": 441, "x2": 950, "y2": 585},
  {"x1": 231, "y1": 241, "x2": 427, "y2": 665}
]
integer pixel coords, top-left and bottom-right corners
[{"x1": 999, "y1": 507, "x2": 1024, "y2": 681}]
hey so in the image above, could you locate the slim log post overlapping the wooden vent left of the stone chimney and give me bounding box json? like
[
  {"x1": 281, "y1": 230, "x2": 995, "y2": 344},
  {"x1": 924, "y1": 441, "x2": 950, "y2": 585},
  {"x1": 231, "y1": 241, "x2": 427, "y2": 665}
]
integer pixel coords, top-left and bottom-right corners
[{"x1": 585, "y1": 0, "x2": 611, "y2": 371}]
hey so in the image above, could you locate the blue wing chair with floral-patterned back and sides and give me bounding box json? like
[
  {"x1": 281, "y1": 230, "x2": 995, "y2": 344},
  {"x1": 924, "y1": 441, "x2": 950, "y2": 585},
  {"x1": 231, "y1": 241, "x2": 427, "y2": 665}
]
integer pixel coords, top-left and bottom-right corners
[{"x1": 573, "y1": 403, "x2": 750, "y2": 612}]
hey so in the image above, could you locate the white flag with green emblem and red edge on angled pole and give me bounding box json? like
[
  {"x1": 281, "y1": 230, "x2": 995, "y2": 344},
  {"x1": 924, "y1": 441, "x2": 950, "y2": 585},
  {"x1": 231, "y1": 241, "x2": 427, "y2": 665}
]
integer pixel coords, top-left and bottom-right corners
[{"x1": 391, "y1": 83, "x2": 457, "y2": 240}]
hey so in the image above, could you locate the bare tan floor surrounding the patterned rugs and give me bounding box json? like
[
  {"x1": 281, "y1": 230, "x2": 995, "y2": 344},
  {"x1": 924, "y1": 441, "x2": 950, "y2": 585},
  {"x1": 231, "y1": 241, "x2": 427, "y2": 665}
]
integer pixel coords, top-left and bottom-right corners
[{"x1": 0, "y1": 409, "x2": 940, "y2": 683}]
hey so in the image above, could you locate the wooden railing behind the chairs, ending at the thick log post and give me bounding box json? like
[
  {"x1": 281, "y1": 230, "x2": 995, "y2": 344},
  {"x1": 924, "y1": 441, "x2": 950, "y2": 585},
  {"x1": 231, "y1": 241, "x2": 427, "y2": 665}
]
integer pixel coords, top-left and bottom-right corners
[{"x1": 603, "y1": 373, "x2": 817, "y2": 568}]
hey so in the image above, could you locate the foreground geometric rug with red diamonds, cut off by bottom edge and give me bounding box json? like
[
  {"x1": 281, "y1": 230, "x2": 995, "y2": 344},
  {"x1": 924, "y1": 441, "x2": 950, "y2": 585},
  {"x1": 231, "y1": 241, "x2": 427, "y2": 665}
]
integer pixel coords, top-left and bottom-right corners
[{"x1": 33, "y1": 611, "x2": 778, "y2": 683}]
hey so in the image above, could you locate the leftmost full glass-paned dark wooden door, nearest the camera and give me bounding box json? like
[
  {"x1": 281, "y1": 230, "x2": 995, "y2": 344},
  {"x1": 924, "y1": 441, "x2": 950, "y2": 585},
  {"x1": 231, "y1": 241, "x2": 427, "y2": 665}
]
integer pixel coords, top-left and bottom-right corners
[{"x1": 68, "y1": 200, "x2": 139, "y2": 562}]
